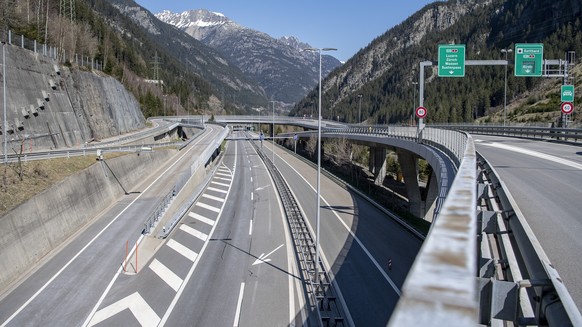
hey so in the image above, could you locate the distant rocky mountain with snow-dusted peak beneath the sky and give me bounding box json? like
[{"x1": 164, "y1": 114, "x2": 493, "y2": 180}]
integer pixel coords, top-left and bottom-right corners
[{"x1": 156, "y1": 10, "x2": 341, "y2": 104}]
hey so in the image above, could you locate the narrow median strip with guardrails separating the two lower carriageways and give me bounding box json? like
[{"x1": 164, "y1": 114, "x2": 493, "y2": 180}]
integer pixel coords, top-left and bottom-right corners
[{"x1": 251, "y1": 142, "x2": 349, "y2": 327}]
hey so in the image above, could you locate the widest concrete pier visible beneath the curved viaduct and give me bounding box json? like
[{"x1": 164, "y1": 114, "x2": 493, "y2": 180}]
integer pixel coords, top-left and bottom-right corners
[{"x1": 396, "y1": 150, "x2": 424, "y2": 217}]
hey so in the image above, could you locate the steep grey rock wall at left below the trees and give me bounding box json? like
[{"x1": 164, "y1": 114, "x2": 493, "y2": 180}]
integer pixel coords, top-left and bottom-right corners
[{"x1": 2, "y1": 46, "x2": 145, "y2": 153}]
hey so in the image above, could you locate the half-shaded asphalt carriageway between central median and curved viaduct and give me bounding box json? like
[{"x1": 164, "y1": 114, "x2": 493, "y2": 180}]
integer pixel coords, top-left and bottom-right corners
[{"x1": 263, "y1": 142, "x2": 421, "y2": 326}]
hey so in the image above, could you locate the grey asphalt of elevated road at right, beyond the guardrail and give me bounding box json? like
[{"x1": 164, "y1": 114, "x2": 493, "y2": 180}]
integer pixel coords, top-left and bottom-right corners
[{"x1": 473, "y1": 135, "x2": 582, "y2": 310}]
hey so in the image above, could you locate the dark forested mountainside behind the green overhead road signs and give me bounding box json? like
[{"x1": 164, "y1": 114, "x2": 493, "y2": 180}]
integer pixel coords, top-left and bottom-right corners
[{"x1": 291, "y1": 0, "x2": 582, "y2": 124}]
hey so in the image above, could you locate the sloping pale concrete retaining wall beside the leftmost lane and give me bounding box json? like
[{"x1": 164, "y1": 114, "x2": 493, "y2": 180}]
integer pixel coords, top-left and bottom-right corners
[{"x1": 0, "y1": 150, "x2": 176, "y2": 290}]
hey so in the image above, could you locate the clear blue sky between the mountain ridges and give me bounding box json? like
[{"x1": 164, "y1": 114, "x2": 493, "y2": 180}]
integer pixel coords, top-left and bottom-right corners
[{"x1": 135, "y1": 0, "x2": 434, "y2": 61}]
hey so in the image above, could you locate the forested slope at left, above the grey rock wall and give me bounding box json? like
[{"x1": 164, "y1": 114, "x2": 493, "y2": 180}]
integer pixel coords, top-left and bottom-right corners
[{"x1": 0, "y1": 0, "x2": 267, "y2": 117}]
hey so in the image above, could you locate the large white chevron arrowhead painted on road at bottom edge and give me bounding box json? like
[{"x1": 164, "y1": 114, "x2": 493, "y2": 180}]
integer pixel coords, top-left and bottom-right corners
[{"x1": 89, "y1": 292, "x2": 160, "y2": 327}]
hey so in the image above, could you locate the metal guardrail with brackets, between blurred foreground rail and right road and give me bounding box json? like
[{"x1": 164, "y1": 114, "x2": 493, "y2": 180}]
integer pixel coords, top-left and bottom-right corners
[{"x1": 478, "y1": 156, "x2": 582, "y2": 326}]
